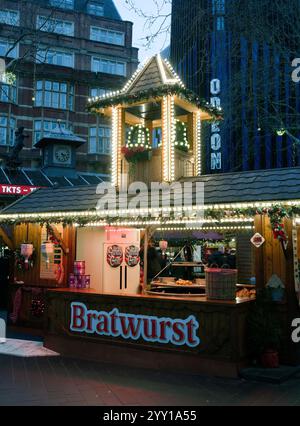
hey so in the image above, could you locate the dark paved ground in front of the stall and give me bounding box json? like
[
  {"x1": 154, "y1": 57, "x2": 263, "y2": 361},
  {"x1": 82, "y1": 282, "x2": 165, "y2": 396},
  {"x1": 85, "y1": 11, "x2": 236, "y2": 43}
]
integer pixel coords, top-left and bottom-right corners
[{"x1": 0, "y1": 354, "x2": 300, "y2": 407}]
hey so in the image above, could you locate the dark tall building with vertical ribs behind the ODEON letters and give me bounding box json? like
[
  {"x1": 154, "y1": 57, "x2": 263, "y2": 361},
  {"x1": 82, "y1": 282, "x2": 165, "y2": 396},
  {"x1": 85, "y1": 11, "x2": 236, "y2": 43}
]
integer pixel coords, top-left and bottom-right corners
[{"x1": 171, "y1": 0, "x2": 300, "y2": 173}]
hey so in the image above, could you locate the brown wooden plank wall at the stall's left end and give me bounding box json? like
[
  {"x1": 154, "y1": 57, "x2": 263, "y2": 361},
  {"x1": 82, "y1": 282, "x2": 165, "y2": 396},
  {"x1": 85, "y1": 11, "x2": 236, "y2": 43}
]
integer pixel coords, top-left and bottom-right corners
[{"x1": 14, "y1": 224, "x2": 76, "y2": 287}]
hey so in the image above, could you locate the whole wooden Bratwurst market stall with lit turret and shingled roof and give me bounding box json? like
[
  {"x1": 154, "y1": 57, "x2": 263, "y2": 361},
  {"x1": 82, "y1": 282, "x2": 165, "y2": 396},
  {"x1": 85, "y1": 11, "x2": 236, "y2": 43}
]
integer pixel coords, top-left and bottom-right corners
[{"x1": 0, "y1": 56, "x2": 300, "y2": 376}]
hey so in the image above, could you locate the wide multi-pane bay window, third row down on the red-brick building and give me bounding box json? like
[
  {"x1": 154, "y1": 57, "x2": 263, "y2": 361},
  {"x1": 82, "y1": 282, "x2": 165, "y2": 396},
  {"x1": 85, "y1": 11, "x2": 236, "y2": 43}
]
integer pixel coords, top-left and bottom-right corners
[{"x1": 35, "y1": 80, "x2": 74, "y2": 111}]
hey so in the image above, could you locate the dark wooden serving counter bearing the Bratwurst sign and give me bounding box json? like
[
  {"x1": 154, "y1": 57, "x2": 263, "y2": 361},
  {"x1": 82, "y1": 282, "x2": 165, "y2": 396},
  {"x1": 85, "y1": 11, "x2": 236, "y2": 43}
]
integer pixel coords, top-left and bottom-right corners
[{"x1": 45, "y1": 289, "x2": 252, "y2": 377}]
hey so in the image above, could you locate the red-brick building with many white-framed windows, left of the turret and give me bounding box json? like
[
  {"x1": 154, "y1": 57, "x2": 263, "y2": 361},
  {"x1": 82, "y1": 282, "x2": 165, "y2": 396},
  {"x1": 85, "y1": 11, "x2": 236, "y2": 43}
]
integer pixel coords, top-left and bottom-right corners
[{"x1": 0, "y1": 0, "x2": 138, "y2": 174}]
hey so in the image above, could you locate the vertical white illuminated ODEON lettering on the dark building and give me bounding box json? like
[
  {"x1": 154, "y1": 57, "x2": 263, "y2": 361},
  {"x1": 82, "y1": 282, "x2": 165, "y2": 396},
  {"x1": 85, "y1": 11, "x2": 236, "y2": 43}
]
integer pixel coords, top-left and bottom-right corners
[{"x1": 210, "y1": 78, "x2": 222, "y2": 170}]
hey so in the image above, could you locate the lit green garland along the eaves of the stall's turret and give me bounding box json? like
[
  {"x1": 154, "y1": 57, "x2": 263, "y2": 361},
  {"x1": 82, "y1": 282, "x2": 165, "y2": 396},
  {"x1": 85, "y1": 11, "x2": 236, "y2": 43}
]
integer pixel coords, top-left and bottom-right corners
[{"x1": 87, "y1": 84, "x2": 222, "y2": 120}]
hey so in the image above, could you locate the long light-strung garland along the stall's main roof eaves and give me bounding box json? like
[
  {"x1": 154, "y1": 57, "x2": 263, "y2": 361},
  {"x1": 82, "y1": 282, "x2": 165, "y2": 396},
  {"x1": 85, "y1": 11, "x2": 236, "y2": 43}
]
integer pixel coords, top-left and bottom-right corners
[{"x1": 0, "y1": 202, "x2": 300, "y2": 248}]
